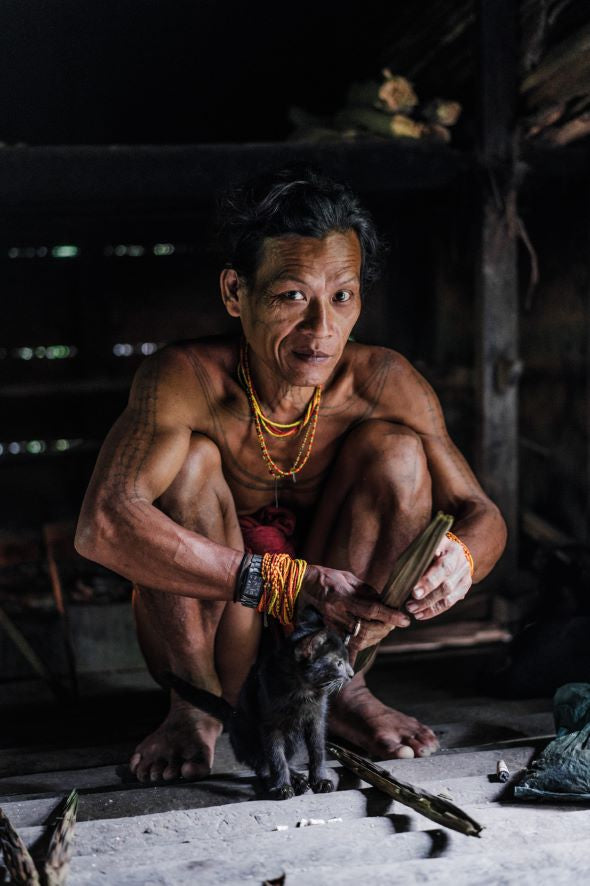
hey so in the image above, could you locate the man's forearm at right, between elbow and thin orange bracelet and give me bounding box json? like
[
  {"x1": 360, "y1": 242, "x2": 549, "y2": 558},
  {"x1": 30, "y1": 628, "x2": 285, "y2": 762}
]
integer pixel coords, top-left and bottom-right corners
[{"x1": 453, "y1": 499, "x2": 507, "y2": 583}]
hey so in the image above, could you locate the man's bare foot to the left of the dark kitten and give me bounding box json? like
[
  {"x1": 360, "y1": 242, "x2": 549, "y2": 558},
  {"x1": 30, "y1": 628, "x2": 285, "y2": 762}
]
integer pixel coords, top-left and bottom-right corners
[{"x1": 129, "y1": 693, "x2": 223, "y2": 781}]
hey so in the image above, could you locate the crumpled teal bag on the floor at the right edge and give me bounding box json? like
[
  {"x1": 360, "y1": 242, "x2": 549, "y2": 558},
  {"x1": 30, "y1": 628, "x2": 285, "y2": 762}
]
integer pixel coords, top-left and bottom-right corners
[{"x1": 514, "y1": 683, "x2": 590, "y2": 803}]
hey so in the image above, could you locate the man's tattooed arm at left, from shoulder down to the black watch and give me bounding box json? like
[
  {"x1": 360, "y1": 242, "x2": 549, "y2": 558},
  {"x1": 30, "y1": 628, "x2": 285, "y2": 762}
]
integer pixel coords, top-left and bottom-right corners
[{"x1": 75, "y1": 348, "x2": 242, "y2": 600}]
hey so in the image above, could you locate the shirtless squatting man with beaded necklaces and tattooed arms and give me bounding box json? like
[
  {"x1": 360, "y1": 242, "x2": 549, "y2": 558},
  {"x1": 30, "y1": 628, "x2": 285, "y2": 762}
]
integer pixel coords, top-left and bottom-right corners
[{"x1": 76, "y1": 171, "x2": 505, "y2": 781}]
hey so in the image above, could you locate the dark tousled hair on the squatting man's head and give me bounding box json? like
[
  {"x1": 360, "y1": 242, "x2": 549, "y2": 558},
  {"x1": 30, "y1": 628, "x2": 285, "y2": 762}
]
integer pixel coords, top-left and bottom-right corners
[{"x1": 218, "y1": 167, "x2": 386, "y2": 290}]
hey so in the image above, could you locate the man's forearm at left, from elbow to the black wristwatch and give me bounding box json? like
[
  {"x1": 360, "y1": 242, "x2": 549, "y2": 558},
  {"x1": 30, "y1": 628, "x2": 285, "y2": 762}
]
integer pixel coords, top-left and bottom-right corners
[{"x1": 75, "y1": 499, "x2": 242, "y2": 600}]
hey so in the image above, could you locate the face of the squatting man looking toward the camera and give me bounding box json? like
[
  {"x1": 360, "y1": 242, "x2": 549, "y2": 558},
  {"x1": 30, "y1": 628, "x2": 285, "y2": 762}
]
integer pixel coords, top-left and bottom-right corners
[{"x1": 222, "y1": 231, "x2": 361, "y2": 386}]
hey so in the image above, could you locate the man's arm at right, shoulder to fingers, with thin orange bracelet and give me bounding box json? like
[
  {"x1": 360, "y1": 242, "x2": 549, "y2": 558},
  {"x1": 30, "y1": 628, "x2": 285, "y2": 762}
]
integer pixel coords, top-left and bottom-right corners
[{"x1": 375, "y1": 354, "x2": 506, "y2": 619}]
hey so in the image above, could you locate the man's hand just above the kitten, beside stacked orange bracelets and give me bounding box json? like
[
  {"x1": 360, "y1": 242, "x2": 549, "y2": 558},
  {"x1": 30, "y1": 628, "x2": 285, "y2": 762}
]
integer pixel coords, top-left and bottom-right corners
[{"x1": 297, "y1": 566, "x2": 410, "y2": 652}]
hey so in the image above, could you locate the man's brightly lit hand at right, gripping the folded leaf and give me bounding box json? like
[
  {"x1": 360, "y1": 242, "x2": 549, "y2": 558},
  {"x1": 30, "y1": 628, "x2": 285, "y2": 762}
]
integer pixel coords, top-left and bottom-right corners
[{"x1": 406, "y1": 538, "x2": 472, "y2": 621}]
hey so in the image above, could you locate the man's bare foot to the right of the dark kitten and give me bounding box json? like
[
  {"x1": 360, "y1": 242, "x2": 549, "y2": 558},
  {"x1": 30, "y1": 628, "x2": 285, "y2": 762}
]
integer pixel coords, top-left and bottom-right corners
[{"x1": 329, "y1": 674, "x2": 438, "y2": 760}]
